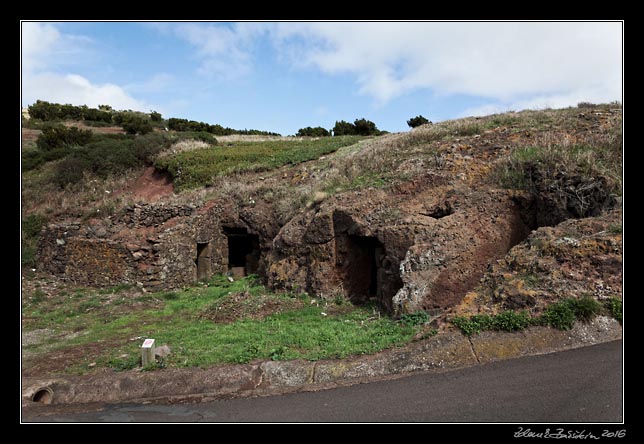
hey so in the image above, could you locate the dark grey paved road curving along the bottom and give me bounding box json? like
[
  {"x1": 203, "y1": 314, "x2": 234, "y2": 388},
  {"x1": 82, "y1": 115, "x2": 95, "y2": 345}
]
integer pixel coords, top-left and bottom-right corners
[{"x1": 26, "y1": 341, "x2": 622, "y2": 423}]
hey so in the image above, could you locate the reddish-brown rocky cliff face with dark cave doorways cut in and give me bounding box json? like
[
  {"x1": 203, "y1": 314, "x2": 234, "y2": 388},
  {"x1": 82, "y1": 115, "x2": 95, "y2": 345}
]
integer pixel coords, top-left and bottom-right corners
[{"x1": 38, "y1": 106, "x2": 621, "y2": 313}]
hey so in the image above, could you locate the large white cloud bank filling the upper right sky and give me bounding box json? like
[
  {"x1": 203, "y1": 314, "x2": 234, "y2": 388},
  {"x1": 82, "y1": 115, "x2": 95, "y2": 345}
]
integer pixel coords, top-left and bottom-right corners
[{"x1": 272, "y1": 22, "x2": 622, "y2": 106}]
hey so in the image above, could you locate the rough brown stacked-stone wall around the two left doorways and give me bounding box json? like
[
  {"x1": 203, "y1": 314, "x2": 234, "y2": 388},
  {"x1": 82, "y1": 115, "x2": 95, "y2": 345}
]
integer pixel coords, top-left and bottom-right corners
[{"x1": 38, "y1": 202, "x2": 278, "y2": 290}]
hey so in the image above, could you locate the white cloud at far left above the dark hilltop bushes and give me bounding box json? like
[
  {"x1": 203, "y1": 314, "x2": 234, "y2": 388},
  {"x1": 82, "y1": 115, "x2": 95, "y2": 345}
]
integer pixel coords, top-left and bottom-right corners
[{"x1": 21, "y1": 22, "x2": 150, "y2": 110}]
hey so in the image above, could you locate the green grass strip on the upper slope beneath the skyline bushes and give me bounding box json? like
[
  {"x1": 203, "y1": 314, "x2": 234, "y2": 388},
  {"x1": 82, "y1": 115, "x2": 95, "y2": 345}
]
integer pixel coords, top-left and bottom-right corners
[{"x1": 156, "y1": 136, "x2": 362, "y2": 190}]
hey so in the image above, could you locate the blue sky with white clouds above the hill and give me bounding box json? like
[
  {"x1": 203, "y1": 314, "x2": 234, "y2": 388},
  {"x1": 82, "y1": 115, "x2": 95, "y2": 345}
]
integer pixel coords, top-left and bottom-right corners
[{"x1": 21, "y1": 22, "x2": 623, "y2": 135}]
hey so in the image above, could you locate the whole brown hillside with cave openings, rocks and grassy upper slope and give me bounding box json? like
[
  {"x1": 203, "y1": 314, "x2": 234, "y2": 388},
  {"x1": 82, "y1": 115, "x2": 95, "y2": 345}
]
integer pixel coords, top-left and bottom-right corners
[{"x1": 22, "y1": 104, "x2": 623, "y2": 374}]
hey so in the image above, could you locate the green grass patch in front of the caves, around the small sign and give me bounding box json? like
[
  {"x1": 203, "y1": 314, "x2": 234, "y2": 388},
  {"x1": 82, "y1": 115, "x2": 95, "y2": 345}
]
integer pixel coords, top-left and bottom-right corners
[{"x1": 23, "y1": 276, "x2": 420, "y2": 373}]
